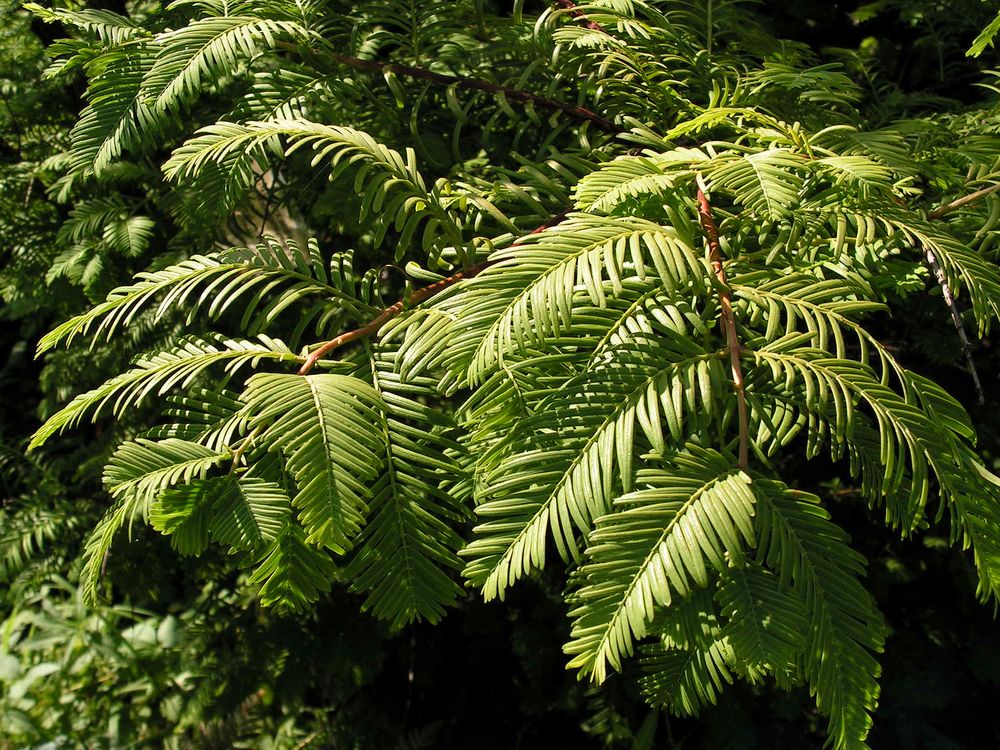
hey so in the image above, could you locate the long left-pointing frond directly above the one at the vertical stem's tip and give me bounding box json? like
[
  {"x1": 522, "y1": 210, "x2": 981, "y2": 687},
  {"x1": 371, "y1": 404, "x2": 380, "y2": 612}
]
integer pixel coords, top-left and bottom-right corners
[{"x1": 464, "y1": 337, "x2": 728, "y2": 599}]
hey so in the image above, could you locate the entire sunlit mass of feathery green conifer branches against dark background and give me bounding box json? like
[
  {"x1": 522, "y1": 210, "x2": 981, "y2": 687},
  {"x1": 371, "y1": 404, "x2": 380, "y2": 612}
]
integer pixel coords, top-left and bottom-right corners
[{"x1": 31, "y1": 0, "x2": 1000, "y2": 750}]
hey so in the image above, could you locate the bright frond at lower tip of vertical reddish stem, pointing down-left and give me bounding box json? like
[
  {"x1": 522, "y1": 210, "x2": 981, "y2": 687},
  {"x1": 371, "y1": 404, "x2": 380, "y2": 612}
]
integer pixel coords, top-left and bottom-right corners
[{"x1": 565, "y1": 446, "x2": 754, "y2": 682}]
